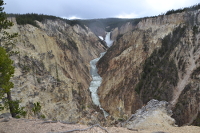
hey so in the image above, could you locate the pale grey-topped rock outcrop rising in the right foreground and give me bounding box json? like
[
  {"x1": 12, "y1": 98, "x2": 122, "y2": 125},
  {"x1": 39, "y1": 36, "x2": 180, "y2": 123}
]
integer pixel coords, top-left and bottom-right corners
[{"x1": 124, "y1": 99, "x2": 175, "y2": 129}]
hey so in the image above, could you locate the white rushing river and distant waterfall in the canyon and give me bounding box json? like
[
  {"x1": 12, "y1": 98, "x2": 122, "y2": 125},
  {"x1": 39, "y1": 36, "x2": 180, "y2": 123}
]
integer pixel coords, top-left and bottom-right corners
[{"x1": 89, "y1": 32, "x2": 113, "y2": 117}]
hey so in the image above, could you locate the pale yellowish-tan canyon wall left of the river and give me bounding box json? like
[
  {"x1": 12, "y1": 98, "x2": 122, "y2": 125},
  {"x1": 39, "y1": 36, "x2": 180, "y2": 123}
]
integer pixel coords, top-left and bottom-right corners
[{"x1": 2, "y1": 18, "x2": 106, "y2": 122}]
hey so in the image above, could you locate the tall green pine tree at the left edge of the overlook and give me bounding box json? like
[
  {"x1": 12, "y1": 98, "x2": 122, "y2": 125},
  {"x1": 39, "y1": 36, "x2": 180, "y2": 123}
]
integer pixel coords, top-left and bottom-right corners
[{"x1": 0, "y1": 0, "x2": 26, "y2": 117}]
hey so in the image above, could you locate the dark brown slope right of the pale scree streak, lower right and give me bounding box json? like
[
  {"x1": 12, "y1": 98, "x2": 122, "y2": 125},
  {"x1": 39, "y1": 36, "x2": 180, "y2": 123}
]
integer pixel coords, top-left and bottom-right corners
[{"x1": 173, "y1": 67, "x2": 200, "y2": 126}]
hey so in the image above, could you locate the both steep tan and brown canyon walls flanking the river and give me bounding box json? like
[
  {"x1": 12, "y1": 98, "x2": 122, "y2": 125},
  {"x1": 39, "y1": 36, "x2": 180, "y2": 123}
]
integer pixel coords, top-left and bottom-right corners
[{"x1": 0, "y1": 9, "x2": 200, "y2": 126}]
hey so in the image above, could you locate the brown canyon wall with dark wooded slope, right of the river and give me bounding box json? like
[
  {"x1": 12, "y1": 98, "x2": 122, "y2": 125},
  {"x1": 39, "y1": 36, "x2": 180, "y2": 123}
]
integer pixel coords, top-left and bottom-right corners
[{"x1": 97, "y1": 10, "x2": 200, "y2": 125}]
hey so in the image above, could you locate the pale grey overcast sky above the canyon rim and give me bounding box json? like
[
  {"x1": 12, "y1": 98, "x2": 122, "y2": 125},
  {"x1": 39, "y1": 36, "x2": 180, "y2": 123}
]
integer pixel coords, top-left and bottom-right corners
[{"x1": 4, "y1": 0, "x2": 200, "y2": 19}]
